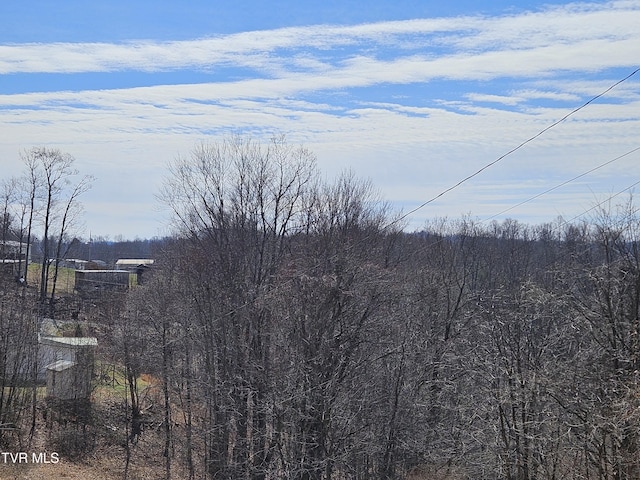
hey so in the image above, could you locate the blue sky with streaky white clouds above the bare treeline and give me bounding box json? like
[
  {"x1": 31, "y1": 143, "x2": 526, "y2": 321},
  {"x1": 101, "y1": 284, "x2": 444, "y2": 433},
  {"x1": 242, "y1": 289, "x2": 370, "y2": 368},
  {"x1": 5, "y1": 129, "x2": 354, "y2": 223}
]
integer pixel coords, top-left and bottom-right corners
[{"x1": 0, "y1": 0, "x2": 640, "y2": 239}]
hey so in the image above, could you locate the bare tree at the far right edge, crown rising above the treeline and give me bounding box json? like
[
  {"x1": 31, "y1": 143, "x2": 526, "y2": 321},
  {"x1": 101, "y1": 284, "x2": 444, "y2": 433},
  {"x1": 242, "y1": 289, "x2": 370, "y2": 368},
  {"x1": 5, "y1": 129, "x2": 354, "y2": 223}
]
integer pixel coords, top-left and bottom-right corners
[{"x1": 565, "y1": 198, "x2": 640, "y2": 480}]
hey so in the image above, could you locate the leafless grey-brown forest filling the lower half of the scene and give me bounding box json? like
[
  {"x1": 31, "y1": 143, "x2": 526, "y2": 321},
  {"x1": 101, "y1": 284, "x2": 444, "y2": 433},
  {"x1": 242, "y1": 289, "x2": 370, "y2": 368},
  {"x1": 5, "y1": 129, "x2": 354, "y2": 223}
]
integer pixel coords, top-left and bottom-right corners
[{"x1": 0, "y1": 137, "x2": 640, "y2": 480}]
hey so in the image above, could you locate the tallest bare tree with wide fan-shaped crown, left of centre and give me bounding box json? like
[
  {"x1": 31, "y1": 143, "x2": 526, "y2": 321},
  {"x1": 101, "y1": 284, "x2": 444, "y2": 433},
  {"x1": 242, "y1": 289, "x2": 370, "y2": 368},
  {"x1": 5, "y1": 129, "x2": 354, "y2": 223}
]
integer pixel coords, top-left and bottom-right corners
[{"x1": 162, "y1": 137, "x2": 316, "y2": 478}]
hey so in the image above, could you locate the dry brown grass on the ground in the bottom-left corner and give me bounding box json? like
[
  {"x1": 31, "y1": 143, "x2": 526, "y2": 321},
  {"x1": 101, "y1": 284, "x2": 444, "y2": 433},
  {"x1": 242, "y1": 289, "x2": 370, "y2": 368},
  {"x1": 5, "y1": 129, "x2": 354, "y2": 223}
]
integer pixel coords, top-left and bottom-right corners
[{"x1": 0, "y1": 365, "x2": 176, "y2": 480}]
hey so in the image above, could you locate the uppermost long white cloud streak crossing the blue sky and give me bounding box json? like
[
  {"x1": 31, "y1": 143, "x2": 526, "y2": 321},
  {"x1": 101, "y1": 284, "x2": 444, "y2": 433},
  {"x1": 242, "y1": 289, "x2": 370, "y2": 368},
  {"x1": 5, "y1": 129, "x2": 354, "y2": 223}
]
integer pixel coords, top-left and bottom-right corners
[{"x1": 0, "y1": 1, "x2": 640, "y2": 78}]
